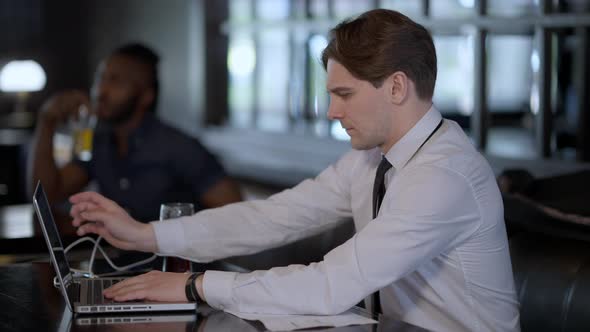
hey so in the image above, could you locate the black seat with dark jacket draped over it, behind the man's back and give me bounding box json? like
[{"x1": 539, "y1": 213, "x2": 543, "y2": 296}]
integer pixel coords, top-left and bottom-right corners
[{"x1": 499, "y1": 169, "x2": 590, "y2": 332}]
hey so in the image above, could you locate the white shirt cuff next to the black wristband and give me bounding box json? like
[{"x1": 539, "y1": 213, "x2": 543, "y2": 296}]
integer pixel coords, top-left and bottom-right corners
[{"x1": 203, "y1": 271, "x2": 238, "y2": 310}]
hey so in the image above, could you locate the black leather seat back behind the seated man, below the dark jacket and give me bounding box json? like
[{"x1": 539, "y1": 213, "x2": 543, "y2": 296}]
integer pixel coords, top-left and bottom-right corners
[{"x1": 510, "y1": 232, "x2": 590, "y2": 332}]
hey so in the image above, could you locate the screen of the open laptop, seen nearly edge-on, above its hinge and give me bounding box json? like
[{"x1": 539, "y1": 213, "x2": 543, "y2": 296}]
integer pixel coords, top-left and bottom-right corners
[{"x1": 33, "y1": 183, "x2": 70, "y2": 279}]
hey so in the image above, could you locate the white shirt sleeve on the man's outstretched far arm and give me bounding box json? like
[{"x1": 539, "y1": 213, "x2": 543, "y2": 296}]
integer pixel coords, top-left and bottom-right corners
[{"x1": 152, "y1": 153, "x2": 353, "y2": 262}]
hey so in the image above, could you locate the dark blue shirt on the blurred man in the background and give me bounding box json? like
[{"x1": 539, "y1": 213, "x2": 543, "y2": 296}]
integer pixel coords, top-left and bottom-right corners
[{"x1": 77, "y1": 113, "x2": 226, "y2": 222}]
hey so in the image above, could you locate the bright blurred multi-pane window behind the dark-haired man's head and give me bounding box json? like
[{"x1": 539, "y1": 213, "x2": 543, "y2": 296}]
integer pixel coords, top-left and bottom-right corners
[{"x1": 221, "y1": 0, "x2": 590, "y2": 161}]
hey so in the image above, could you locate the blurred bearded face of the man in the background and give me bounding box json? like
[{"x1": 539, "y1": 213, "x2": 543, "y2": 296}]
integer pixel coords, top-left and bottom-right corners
[{"x1": 90, "y1": 55, "x2": 146, "y2": 124}]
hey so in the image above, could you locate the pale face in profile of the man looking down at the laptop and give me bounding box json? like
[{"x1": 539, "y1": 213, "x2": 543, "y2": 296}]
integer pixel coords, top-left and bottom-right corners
[{"x1": 326, "y1": 59, "x2": 393, "y2": 150}]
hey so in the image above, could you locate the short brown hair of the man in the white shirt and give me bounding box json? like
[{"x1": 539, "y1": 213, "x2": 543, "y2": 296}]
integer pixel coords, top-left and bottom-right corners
[{"x1": 322, "y1": 9, "x2": 436, "y2": 100}]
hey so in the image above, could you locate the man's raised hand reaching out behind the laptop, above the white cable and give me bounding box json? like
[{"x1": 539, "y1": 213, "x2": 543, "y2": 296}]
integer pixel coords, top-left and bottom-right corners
[{"x1": 70, "y1": 192, "x2": 157, "y2": 252}]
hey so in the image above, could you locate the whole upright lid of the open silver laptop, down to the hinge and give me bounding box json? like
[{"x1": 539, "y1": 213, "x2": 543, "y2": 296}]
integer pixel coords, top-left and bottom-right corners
[{"x1": 33, "y1": 181, "x2": 73, "y2": 311}]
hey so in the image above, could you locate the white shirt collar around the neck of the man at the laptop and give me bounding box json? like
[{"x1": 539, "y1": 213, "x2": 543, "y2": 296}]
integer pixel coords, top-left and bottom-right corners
[{"x1": 385, "y1": 105, "x2": 442, "y2": 170}]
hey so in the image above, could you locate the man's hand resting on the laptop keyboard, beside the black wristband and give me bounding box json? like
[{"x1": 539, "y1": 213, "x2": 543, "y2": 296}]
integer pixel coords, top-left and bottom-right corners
[{"x1": 103, "y1": 271, "x2": 190, "y2": 302}]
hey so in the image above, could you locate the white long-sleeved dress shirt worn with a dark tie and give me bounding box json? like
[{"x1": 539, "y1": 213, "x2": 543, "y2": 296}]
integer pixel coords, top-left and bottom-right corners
[{"x1": 153, "y1": 108, "x2": 519, "y2": 332}]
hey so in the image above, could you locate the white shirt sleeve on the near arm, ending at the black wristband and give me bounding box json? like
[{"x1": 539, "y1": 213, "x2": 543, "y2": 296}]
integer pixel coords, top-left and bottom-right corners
[{"x1": 203, "y1": 166, "x2": 481, "y2": 315}]
